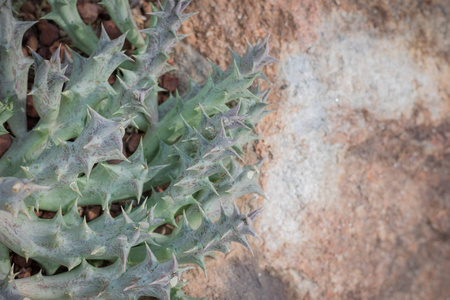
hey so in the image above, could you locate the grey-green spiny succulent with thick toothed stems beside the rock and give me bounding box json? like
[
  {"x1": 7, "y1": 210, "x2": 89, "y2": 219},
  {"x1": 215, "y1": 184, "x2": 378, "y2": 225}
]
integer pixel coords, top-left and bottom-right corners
[{"x1": 0, "y1": 0, "x2": 275, "y2": 299}]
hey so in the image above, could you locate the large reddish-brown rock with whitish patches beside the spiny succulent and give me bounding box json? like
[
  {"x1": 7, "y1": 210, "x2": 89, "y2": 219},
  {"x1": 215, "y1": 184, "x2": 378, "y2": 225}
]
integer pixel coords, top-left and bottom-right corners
[{"x1": 176, "y1": 0, "x2": 450, "y2": 299}]
